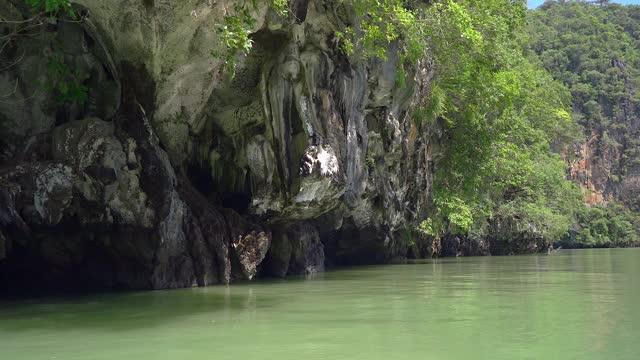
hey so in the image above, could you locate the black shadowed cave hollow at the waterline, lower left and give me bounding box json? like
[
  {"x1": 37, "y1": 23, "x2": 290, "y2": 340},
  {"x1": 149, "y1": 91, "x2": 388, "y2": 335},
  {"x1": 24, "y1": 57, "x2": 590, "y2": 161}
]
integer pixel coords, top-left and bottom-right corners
[{"x1": 0, "y1": 224, "x2": 149, "y2": 298}]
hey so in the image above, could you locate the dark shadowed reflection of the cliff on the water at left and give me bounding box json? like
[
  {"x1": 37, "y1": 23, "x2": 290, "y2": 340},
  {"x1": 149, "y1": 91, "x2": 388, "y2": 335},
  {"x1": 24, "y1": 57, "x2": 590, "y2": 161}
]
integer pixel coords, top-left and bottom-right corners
[{"x1": 0, "y1": 286, "x2": 276, "y2": 332}]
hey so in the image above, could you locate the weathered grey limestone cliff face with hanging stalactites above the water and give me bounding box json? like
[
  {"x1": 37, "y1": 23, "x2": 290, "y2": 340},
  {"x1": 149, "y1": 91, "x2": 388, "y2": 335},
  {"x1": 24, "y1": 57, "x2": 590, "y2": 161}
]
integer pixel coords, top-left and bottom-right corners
[{"x1": 0, "y1": 0, "x2": 440, "y2": 291}]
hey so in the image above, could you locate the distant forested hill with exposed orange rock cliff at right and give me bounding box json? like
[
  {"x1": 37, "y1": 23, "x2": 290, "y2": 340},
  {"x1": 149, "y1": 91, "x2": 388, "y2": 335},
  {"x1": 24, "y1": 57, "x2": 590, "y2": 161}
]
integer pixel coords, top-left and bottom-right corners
[{"x1": 528, "y1": 1, "x2": 640, "y2": 246}]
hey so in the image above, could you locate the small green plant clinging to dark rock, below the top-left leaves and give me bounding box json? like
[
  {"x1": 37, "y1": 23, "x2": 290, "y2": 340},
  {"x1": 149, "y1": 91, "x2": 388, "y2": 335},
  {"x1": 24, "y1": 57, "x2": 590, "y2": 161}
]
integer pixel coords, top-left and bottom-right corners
[{"x1": 47, "y1": 56, "x2": 89, "y2": 105}]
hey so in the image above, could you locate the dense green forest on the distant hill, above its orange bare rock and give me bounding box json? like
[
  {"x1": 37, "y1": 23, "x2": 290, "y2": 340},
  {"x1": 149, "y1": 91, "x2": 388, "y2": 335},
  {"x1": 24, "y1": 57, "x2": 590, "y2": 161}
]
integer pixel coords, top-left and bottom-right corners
[{"x1": 528, "y1": 1, "x2": 640, "y2": 205}]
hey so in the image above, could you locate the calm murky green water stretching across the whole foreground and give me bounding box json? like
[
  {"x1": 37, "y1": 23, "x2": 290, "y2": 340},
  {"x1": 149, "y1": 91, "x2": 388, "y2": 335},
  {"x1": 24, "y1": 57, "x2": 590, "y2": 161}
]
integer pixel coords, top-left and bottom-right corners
[{"x1": 0, "y1": 249, "x2": 640, "y2": 360}]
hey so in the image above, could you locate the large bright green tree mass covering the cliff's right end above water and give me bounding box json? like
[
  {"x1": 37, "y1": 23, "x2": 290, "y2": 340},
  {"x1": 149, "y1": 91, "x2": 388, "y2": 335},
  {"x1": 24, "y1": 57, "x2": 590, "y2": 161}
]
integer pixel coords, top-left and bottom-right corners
[{"x1": 416, "y1": 0, "x2": 580, "y2": 248}]
